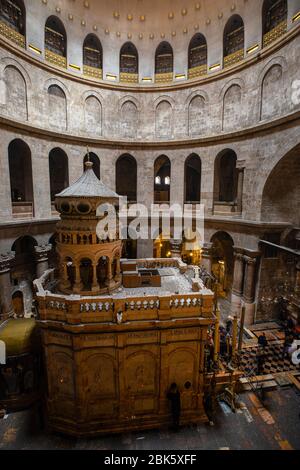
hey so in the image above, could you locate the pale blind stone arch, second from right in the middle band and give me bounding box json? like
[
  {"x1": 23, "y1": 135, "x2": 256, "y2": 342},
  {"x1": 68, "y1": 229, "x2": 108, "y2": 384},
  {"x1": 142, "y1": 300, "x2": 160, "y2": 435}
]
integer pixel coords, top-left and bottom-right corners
[{"x1": 222, "y1": 83, "x2": 242, "y2": 131}]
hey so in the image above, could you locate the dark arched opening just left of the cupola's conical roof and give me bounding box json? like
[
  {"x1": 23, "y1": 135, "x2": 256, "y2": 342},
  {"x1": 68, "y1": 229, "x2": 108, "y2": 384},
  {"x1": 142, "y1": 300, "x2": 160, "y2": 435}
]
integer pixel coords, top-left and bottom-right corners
[{"x1": 49, "y1": 148, "x2": 69, "y2": 202}]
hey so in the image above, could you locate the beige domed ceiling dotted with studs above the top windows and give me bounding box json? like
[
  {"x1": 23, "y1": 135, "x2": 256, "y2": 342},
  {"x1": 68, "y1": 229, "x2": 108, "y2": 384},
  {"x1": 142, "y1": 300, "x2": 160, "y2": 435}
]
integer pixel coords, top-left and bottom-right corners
[{"x1": 40, "y1": 0, "x2": 246, "y2": 40}]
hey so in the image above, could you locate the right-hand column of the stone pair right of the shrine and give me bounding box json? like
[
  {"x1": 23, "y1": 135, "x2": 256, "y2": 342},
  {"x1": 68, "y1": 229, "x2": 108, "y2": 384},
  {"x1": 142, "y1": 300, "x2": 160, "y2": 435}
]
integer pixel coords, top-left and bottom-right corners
[{"x1": 243, "y1": 256, "x2": 257, "y2": 326}]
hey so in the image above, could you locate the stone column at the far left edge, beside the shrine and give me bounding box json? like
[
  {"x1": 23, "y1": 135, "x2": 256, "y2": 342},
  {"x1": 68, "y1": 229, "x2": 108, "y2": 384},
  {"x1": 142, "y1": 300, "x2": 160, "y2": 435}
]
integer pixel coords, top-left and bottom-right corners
[{"x1": 0, "y1": 251, "x2": 15, "y2": 320}]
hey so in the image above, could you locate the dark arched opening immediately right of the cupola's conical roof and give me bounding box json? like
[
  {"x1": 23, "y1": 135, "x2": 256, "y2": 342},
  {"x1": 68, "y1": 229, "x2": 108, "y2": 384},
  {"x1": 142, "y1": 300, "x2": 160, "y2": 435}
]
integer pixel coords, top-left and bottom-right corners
[{"x1": 116, "y1": 155, "x2": 137, "y2": 202}]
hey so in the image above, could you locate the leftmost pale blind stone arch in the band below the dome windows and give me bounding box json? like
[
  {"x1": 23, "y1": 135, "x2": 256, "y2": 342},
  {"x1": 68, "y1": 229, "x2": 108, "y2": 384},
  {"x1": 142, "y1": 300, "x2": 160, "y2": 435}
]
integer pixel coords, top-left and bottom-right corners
[{"x1": 4, "y1": 65, "x2": 28, "y2": 121}]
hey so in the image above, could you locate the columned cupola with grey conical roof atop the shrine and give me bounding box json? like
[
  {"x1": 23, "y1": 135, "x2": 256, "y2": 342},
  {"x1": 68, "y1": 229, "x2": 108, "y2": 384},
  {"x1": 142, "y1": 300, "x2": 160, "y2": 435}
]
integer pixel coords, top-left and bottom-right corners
[{"x1": 55, "y1": 161, "x2": 122, "y2": 295}]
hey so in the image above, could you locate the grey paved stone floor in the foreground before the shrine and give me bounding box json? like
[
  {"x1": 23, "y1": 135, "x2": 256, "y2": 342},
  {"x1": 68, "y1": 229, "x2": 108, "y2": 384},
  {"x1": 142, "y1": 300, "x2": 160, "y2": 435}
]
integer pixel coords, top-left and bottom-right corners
[{"x1": 0, "y1": 387, "x2": 300, "y2": 451}]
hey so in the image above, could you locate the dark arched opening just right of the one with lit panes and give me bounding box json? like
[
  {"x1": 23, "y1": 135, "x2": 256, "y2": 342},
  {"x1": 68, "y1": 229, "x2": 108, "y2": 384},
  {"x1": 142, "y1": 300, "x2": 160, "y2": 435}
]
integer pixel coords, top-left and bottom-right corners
[{"x1": 184, "y1": 154, "x2": 201, "y2": 203}]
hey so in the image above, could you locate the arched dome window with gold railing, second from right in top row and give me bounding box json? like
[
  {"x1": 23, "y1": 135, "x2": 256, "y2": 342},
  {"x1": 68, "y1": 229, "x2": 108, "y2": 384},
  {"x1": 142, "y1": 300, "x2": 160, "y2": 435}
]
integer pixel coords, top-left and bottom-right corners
[{"x1": 223, "y1": 15, "x2": 245, "y2": 67}]
